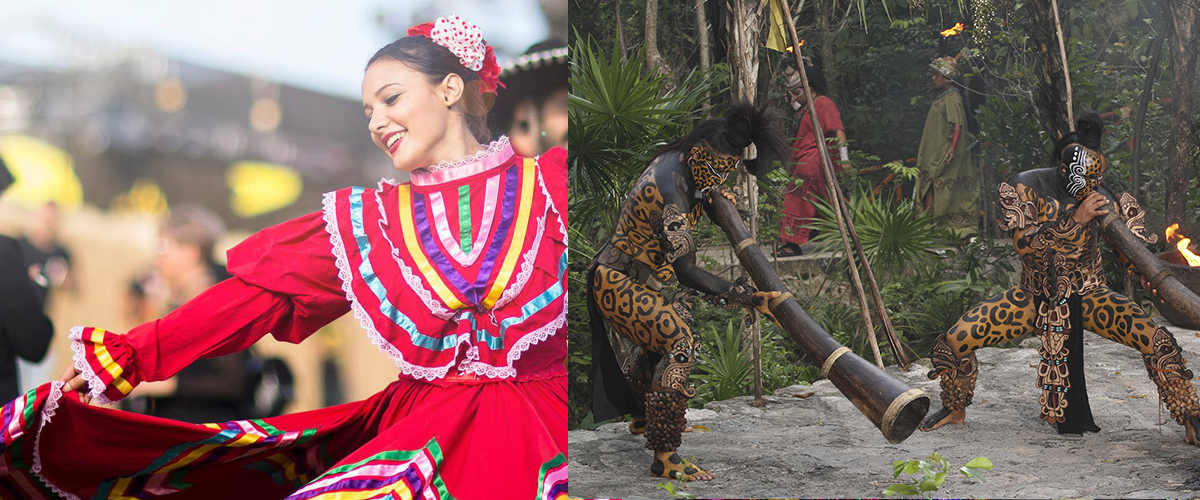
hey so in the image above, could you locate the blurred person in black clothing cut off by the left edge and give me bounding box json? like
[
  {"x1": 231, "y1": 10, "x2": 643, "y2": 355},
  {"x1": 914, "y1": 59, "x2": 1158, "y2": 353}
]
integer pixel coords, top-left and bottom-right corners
[{"x1": 0, "y1": 159, "x2": 54, "y2": 400}]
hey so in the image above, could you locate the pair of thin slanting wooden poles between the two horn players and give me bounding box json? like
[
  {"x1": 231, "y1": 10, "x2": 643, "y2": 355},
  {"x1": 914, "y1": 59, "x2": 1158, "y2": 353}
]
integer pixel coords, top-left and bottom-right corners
[{"x1": 779, "y1": 0, "x2": 910, "y2": 369}]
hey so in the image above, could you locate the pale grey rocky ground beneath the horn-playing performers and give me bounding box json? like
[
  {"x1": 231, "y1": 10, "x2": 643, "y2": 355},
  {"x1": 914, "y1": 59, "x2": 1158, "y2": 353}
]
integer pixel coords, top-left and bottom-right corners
[{"x1": 569, "y1": 319, "x2": 1200, "y2": 499}]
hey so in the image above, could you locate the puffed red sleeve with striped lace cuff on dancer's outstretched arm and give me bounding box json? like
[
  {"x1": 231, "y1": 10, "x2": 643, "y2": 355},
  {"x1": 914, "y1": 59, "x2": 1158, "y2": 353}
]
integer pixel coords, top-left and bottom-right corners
[{"x1": 71, "y1": 208, "x2": 349, "y2": 404}]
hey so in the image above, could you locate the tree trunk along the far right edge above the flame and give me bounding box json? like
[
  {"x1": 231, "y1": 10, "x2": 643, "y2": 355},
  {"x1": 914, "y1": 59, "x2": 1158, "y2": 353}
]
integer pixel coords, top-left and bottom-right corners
[{"x1": 1163, "y1": 0, "x2": 1200, "y2": 224}]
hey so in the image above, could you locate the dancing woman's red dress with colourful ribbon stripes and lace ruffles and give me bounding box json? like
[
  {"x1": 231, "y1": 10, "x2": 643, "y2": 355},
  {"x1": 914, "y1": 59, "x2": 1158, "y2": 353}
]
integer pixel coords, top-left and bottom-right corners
[{"x1": 0, "y1": 138, "x2": 566, "y2": 500}]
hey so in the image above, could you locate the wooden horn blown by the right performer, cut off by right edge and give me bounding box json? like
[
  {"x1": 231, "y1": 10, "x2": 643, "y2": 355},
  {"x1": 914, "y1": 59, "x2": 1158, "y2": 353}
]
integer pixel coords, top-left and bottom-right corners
[{"x1": 1100, "y1": 201, "x2": 1200, "y2": 325}]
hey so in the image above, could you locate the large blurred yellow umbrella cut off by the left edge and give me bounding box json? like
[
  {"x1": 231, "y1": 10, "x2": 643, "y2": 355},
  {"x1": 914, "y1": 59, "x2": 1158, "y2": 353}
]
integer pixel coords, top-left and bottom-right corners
[{"x1": 0, "y1": 134, "x2": 83, "y2": 209}]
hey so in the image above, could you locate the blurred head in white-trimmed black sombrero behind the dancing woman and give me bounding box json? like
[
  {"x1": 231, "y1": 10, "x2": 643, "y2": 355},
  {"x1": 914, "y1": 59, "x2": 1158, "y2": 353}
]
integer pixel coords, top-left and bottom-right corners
[{"x1": 492, "y1": 40, "x2": 568, "y2": 156}]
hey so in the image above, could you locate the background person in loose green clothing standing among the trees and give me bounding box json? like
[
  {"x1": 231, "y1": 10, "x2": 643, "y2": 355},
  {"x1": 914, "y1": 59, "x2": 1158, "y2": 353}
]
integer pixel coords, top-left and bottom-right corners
[{"x1": 913, "y1": 54, "x2": 979, "y2": 237}]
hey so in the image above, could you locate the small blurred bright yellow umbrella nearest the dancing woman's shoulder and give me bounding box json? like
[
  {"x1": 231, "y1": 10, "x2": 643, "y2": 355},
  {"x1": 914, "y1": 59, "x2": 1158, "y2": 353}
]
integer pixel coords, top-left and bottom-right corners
[{"x1": 226, "y1": 162, "x2": 304, "y2": 218}]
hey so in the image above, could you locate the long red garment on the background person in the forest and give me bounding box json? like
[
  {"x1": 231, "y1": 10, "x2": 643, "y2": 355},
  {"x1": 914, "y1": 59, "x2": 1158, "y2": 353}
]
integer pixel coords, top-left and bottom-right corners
[{"x1": 779, "y1": 96, "x2": 845, "y2": 245}]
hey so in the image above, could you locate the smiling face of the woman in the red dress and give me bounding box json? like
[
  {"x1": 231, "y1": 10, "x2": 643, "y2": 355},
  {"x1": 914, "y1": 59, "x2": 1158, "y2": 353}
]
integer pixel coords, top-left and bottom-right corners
[{"x1": 362, "y1": 59, "x2": 462, "y2": 171}]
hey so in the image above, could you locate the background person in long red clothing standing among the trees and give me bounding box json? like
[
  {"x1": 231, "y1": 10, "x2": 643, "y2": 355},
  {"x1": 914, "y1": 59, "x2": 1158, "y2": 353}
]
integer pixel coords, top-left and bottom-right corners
[{"x1": 776, "y1": 58, "x2": 850, "y2": 257}]
